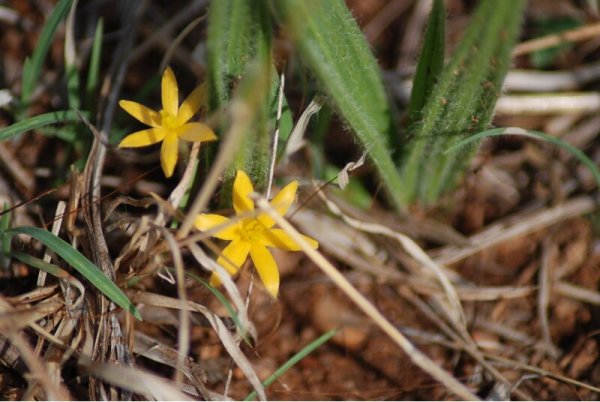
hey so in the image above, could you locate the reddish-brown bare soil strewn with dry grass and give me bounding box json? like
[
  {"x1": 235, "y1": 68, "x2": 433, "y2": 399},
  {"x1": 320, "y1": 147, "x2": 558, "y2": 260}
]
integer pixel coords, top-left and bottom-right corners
[{"x1": 0, "y1": 0, "x2": 600, "y2": 400}]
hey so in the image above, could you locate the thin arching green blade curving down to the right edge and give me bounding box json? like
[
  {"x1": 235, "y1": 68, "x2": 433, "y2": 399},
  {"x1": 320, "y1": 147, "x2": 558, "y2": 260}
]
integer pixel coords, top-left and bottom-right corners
[{"x1": 445, "y1": 127, "x2": 600, "y2": 188}]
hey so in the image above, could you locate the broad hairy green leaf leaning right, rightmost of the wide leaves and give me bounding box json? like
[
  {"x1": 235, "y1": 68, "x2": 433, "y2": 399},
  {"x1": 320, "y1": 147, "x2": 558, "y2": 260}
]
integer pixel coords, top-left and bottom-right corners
[{"x1": 401, "y1": 0, "x2": 525, "y2": 205}]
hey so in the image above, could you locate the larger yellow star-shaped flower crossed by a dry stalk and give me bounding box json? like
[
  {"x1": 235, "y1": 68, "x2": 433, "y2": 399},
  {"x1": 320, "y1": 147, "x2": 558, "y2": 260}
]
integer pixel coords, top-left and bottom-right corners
[{"x1": 195, "y1": 170, "x2": 319, "y2": 298}]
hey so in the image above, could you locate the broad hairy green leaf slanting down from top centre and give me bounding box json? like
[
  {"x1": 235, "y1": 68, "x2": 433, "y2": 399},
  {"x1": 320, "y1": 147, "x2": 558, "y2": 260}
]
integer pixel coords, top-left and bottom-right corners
[{"x1": 271, "y1": 0, "x2": 403, "y2": 214}]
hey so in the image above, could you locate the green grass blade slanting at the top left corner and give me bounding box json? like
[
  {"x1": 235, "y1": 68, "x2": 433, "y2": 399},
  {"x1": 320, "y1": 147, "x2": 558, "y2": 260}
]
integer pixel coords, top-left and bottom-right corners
[{"x1": 21, "y1": 0, "x2": 73, "y2": 105}]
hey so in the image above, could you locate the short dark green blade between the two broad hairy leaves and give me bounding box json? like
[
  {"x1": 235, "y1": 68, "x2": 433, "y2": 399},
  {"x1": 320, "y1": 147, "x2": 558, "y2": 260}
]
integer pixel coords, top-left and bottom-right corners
[{"x1": 408, "y1": 0, "x2": 446, "y2": 124}]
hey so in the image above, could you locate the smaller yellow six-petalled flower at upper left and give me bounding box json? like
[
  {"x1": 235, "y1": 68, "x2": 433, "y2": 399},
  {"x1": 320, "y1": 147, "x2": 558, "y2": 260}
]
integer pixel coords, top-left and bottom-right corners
[{"x1": 119, "y1": 67, "x2": 217, "y2": 177}]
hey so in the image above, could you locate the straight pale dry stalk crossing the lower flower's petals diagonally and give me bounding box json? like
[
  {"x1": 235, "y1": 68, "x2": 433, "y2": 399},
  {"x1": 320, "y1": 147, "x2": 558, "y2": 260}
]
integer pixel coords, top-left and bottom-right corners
[{"x1": 255, "y1": 196, "x2": 479, "y2": 400}]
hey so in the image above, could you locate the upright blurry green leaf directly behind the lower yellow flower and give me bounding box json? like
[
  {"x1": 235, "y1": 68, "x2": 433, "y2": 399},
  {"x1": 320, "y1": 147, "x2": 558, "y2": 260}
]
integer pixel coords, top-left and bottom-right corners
[{"x1": 207, "y1": 0, "x2": 292, "y2": 199}]
